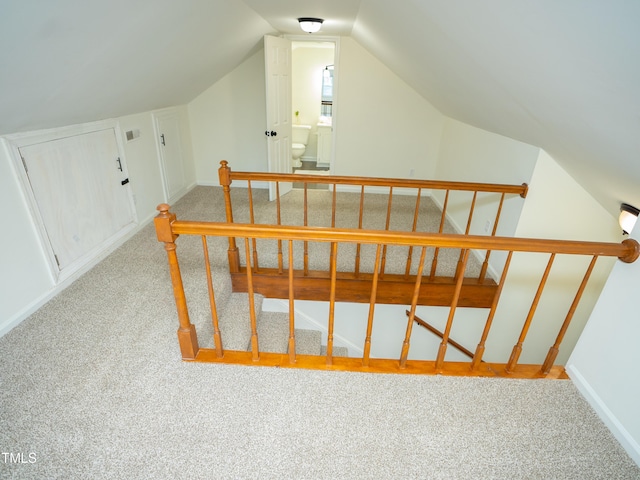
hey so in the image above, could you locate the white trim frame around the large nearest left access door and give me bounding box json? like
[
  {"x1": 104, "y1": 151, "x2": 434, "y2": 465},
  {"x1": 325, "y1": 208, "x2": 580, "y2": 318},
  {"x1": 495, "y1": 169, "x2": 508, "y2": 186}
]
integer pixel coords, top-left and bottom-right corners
[{"x1": 4, "y1": 119, "x2": 138, "y2": 284}]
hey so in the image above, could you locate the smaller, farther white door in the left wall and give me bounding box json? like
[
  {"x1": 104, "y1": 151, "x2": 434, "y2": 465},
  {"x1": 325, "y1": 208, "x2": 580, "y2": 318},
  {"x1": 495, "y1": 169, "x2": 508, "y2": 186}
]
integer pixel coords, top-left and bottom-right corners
[{"x1": 154, "y1": 112, "x2": 187, "y2": 203}]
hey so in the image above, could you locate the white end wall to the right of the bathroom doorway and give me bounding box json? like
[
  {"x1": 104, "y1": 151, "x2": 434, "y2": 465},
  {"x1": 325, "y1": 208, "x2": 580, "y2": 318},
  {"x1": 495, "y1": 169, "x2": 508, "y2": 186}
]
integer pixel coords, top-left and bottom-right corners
[{"x1": 334, "y1": 37, "x2": 444, "y2": 178}]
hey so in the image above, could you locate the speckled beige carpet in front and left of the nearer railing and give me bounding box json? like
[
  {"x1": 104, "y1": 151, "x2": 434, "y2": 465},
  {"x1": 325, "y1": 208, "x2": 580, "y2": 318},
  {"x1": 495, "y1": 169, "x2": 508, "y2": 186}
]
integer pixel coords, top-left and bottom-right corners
[{"x1": 0, "y1": 187, "x2": 640, "y2": 480}]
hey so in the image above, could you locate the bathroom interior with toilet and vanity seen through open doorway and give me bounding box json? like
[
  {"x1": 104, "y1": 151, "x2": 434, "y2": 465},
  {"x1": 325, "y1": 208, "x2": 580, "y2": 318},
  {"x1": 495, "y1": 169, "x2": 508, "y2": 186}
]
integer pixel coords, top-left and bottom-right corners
[{"x1": 291, "y1": 41, "x2": 335, "y2": 182}]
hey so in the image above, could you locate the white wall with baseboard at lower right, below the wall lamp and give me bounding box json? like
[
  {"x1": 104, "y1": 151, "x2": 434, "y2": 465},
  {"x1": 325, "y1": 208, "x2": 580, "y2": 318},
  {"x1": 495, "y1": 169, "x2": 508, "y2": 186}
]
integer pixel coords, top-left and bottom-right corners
[{"x1": 567, "y1": 228, "x2": 640, "y2": 465}]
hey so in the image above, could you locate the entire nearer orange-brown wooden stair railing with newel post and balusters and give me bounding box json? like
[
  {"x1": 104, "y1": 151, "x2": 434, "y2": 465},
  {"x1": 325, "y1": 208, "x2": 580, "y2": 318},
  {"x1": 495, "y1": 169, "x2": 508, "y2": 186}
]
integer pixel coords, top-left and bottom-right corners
[{"x1": 154, "y1": 204, "x2": 640, "y2": 378}]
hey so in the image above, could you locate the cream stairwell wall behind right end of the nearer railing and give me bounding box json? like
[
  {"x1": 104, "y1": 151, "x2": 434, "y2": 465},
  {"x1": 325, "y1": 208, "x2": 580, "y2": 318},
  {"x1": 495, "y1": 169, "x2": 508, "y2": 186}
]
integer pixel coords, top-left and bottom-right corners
[{"x1": 487, "y1": 150, "x2": 622, "y2": 364}]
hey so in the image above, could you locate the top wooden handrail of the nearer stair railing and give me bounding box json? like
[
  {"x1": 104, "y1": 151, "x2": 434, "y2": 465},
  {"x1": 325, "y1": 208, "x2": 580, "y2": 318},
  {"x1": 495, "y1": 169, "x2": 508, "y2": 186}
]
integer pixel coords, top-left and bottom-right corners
[{"x1": 158, "y1": 216, "x2": 640, "y2": 263}]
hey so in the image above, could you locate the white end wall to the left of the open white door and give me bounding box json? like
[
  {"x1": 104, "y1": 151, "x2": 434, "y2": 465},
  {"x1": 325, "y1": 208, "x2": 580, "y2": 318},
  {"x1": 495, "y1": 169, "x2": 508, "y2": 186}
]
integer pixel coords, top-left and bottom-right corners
[{"x1": 188, "y1": 49, "x2": 267, "y2": 185}]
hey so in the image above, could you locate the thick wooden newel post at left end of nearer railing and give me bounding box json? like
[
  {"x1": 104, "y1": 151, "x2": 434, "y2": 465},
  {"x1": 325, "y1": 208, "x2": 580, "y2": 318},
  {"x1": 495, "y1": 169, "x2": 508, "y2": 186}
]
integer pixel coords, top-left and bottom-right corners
[{"x1": 153, "y1": 203, "x2": 199, "y2": 360}]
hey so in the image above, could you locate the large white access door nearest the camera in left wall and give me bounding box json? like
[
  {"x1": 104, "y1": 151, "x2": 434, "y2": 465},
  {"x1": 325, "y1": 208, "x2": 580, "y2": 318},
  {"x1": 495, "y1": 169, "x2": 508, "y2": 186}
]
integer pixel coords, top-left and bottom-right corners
[{"x1": 19, "y1": 129, "x2": 134, "y2": 271}]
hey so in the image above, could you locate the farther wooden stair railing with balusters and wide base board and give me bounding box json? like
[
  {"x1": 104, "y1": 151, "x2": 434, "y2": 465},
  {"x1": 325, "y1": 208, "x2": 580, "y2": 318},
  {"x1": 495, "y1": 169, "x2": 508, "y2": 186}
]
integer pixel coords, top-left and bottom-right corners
[{"x1": 218, "y1": 160, "x2": 528, "y2": 308}]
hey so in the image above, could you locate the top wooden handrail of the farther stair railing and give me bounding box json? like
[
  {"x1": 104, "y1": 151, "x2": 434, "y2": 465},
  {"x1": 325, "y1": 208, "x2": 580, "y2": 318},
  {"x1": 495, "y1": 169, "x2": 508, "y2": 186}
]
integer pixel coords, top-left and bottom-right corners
[{"x1": 220, "y1": 160, "x2": 528, "y2": 198}]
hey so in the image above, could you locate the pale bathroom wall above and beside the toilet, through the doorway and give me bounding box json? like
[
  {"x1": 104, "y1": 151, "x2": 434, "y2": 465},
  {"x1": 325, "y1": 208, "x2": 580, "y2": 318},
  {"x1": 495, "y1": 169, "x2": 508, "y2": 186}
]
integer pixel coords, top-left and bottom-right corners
[{"x1": 291, "y1": 42, "x2": 335, "y2": 161}]
